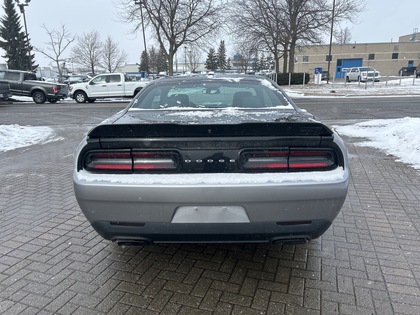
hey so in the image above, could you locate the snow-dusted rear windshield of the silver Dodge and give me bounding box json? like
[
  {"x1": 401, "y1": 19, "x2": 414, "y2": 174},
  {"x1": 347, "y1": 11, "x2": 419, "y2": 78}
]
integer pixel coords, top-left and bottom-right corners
[{"x1": 132, "y1": 79, "x2": 293, "y2": 109}]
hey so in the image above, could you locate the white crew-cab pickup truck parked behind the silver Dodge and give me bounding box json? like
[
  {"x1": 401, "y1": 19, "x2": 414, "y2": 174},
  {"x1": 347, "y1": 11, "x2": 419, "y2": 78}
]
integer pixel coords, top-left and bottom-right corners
[{"x1": 69, "y1": 73, "x2": 148, "y2": 103}]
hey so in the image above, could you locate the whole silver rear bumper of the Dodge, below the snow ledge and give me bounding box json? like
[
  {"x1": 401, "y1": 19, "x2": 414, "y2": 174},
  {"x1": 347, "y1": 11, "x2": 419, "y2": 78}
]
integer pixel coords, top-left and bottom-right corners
[{"x1": 74, "y1": 171, "x2": 348, "y2": 243}]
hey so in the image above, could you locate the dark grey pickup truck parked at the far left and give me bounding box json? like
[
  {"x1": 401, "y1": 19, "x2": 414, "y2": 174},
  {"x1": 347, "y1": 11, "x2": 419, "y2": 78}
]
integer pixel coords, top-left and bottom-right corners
[{"x1": 0, "y1": 69, "x2": 68, "y2": 104}]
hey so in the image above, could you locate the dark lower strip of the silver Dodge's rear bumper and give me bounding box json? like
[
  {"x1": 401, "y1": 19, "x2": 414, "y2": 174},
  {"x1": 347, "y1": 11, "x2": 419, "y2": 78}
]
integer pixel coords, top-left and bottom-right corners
[{"x1": 92, "y1": 220, "x2": 332, "y2": 246}]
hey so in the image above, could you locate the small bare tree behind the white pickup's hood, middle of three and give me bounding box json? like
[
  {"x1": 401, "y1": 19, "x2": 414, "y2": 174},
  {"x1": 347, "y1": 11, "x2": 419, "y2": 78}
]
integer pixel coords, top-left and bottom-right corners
[{"x1": 72, "y1": 31, "x2": 103, "y2": 74}]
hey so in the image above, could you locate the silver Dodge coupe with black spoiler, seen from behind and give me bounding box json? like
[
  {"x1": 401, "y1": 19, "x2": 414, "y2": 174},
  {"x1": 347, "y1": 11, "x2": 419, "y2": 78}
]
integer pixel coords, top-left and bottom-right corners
[{"x1": 73, "y1": 74, "x2": 349, "y2": 245}]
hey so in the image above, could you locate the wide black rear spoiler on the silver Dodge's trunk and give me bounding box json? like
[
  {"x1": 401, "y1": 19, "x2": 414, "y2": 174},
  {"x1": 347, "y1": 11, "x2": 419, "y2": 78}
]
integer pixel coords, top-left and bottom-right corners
[{"x1": 88, "y1": 122, "x2": 333, "y2": 139}]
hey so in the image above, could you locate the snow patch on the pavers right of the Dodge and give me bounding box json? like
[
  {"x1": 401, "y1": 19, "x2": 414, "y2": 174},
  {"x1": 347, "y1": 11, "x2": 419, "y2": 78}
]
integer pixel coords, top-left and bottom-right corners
[{"x1": 334, "y1": 117, "x2": 420, "y2": 169}]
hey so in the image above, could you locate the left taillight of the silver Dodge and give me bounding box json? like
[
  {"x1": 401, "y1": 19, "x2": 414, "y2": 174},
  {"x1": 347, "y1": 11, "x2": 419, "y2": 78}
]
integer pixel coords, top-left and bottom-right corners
[{"x1": 83, "y1": 150, "x2": 179, "y2": 173}]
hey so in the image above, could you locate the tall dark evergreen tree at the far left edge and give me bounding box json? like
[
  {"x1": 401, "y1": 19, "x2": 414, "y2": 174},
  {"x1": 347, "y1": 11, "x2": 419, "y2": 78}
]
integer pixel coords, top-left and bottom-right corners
[{"x1": 0, "y1": 0, "x2": 38, "y2": 70}]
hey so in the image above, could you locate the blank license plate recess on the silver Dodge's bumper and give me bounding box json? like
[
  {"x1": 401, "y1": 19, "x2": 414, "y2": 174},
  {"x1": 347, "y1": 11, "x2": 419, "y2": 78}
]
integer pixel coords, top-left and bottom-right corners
[{"x1": 171, "y1": 206, "x2": 250, "y2": 224}]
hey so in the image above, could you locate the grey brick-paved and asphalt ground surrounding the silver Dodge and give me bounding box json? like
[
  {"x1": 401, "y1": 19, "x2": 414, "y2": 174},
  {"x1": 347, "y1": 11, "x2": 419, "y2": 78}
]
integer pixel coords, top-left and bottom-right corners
[{"x1": 0, "y1": 100, "x2": 420, "y2": 315}]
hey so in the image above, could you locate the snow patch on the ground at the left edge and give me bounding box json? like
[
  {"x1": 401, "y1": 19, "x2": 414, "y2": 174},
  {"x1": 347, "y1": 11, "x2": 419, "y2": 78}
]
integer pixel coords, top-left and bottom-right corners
[{"x1": 0, "y1": 124, "x2": 63, "y2": 152}]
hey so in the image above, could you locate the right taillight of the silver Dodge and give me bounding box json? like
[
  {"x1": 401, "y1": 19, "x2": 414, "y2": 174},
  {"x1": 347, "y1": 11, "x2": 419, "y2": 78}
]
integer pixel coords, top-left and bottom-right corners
[{"x1": 240, "y1": 148, "x2": 338, "y2": 172}]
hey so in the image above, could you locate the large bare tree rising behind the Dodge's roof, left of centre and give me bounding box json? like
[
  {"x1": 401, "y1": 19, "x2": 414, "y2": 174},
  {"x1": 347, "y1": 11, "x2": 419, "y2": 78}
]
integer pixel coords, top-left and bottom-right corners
[{"x1": 120, "y1": 0, "x2": 225, "y2": 75}]
